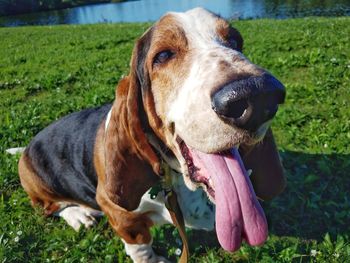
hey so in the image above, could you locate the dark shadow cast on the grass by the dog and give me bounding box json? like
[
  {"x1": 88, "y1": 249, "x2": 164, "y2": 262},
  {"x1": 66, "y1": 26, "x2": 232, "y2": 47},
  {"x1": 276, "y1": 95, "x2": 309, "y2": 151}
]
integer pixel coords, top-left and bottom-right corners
[{"x1": 154, "y1": 151, "x2": 350, "y2": 253}]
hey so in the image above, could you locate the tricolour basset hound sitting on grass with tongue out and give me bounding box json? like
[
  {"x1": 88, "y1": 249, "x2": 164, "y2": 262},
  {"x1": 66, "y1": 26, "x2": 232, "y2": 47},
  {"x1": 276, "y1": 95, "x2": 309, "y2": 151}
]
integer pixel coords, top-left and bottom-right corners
[{"x1": 19, "y1": 8, "x2": 285, "y2": 262}]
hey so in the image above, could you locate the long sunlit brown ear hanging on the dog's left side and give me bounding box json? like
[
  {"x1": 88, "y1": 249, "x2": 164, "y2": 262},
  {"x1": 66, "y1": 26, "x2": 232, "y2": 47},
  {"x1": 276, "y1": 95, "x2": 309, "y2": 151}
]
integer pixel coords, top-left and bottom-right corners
[{"x1": 104, "y1": 27, "x2": 160, "y2": 210}]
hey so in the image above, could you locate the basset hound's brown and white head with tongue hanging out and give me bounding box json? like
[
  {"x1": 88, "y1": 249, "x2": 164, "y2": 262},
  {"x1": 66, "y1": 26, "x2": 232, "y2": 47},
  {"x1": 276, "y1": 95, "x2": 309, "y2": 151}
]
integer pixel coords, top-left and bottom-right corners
[{"x1": 107, "y1": 8, "x2": 285, "y2": 250}]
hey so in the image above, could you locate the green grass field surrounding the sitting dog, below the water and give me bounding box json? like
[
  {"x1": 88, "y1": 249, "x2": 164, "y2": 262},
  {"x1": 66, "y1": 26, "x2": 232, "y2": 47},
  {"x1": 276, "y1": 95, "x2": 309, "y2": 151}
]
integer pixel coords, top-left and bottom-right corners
[{"x1": 0, "y1": 18, "x2": 350, "y2": 263}]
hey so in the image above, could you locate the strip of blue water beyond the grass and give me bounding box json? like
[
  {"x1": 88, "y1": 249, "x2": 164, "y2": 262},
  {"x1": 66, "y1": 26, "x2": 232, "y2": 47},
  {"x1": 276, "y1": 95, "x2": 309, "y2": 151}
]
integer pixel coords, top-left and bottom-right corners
[{"x1": 0, "y1": 0, "x2": 350, "y2": 26}]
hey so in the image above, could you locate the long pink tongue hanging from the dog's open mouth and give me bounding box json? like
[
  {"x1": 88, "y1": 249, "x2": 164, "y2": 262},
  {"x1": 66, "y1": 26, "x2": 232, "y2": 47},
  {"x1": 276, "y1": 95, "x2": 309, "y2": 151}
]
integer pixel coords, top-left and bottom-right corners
[{"x1": 189, "y1": 148, "x2": 268, "y2": 251}]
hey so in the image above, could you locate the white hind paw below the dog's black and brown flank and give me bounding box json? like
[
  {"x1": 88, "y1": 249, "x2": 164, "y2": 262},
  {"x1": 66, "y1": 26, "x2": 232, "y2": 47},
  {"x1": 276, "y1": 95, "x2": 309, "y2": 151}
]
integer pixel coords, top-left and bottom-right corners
[{"x1": 57, "y1": 206, "x2": 103, "y2": 231}]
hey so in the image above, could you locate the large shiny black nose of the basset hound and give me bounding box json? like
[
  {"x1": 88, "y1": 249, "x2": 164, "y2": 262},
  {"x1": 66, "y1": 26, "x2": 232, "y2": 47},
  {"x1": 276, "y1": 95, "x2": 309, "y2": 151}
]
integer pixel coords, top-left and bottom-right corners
[{"x1": 211, "y1": 73, "x2": 285, "y2": 131}]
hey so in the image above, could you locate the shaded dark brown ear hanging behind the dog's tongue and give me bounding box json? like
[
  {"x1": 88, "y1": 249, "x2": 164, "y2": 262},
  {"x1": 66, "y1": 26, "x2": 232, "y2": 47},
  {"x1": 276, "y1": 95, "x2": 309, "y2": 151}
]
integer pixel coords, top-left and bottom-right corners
[{"x1": 240, "y1": 129, "x2": 286, "y2": 200}]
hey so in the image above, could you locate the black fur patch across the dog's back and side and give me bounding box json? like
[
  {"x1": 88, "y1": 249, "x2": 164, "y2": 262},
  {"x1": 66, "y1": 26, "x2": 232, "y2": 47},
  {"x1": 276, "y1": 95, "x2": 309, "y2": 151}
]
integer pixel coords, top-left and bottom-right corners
[{"x1": 26, "y1": 104, "x2": 112, "y2": 209}]
